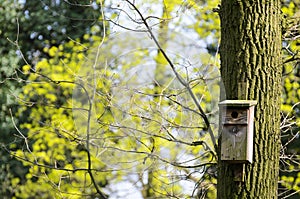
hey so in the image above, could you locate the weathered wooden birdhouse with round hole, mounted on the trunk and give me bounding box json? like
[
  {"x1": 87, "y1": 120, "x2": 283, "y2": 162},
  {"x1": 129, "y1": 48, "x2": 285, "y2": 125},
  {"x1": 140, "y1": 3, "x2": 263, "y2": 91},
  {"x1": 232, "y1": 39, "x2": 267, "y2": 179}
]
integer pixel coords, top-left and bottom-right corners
[{"x1": 219, "y1": 100, "x2": 257, "y2": 163}]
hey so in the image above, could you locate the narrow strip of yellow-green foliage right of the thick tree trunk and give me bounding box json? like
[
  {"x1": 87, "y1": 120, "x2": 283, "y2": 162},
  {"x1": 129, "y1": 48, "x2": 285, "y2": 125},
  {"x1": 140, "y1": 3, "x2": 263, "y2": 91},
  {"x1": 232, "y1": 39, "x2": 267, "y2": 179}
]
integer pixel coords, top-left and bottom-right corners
[{"x1": 279, "y1": 0, "x2": 300, "y2": 199}]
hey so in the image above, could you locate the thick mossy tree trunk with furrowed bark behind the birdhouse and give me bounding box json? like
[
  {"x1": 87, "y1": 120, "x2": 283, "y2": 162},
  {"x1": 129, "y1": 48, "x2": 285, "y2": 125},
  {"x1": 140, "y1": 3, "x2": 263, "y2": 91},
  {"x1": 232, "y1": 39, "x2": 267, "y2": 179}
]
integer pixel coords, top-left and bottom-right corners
[{"x1": 218, "y1": 0, "x2": 282, "y2": 199}]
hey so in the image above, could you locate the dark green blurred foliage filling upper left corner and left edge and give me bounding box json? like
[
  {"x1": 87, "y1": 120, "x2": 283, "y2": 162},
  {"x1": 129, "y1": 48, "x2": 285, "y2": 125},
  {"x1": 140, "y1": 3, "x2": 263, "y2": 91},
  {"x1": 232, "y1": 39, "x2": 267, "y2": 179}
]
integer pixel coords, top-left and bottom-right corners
[{"x1": 0, "y1": 0, "x2": 102, "y2": 198}]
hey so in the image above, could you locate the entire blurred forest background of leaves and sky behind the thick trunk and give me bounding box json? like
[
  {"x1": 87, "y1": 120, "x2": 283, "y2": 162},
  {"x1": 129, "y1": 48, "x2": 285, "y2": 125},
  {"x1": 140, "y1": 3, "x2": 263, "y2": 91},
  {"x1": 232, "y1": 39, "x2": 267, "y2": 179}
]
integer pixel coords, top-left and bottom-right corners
[{"x1": 0, "y1": 0, "x2": 300, "y2": 198}]
